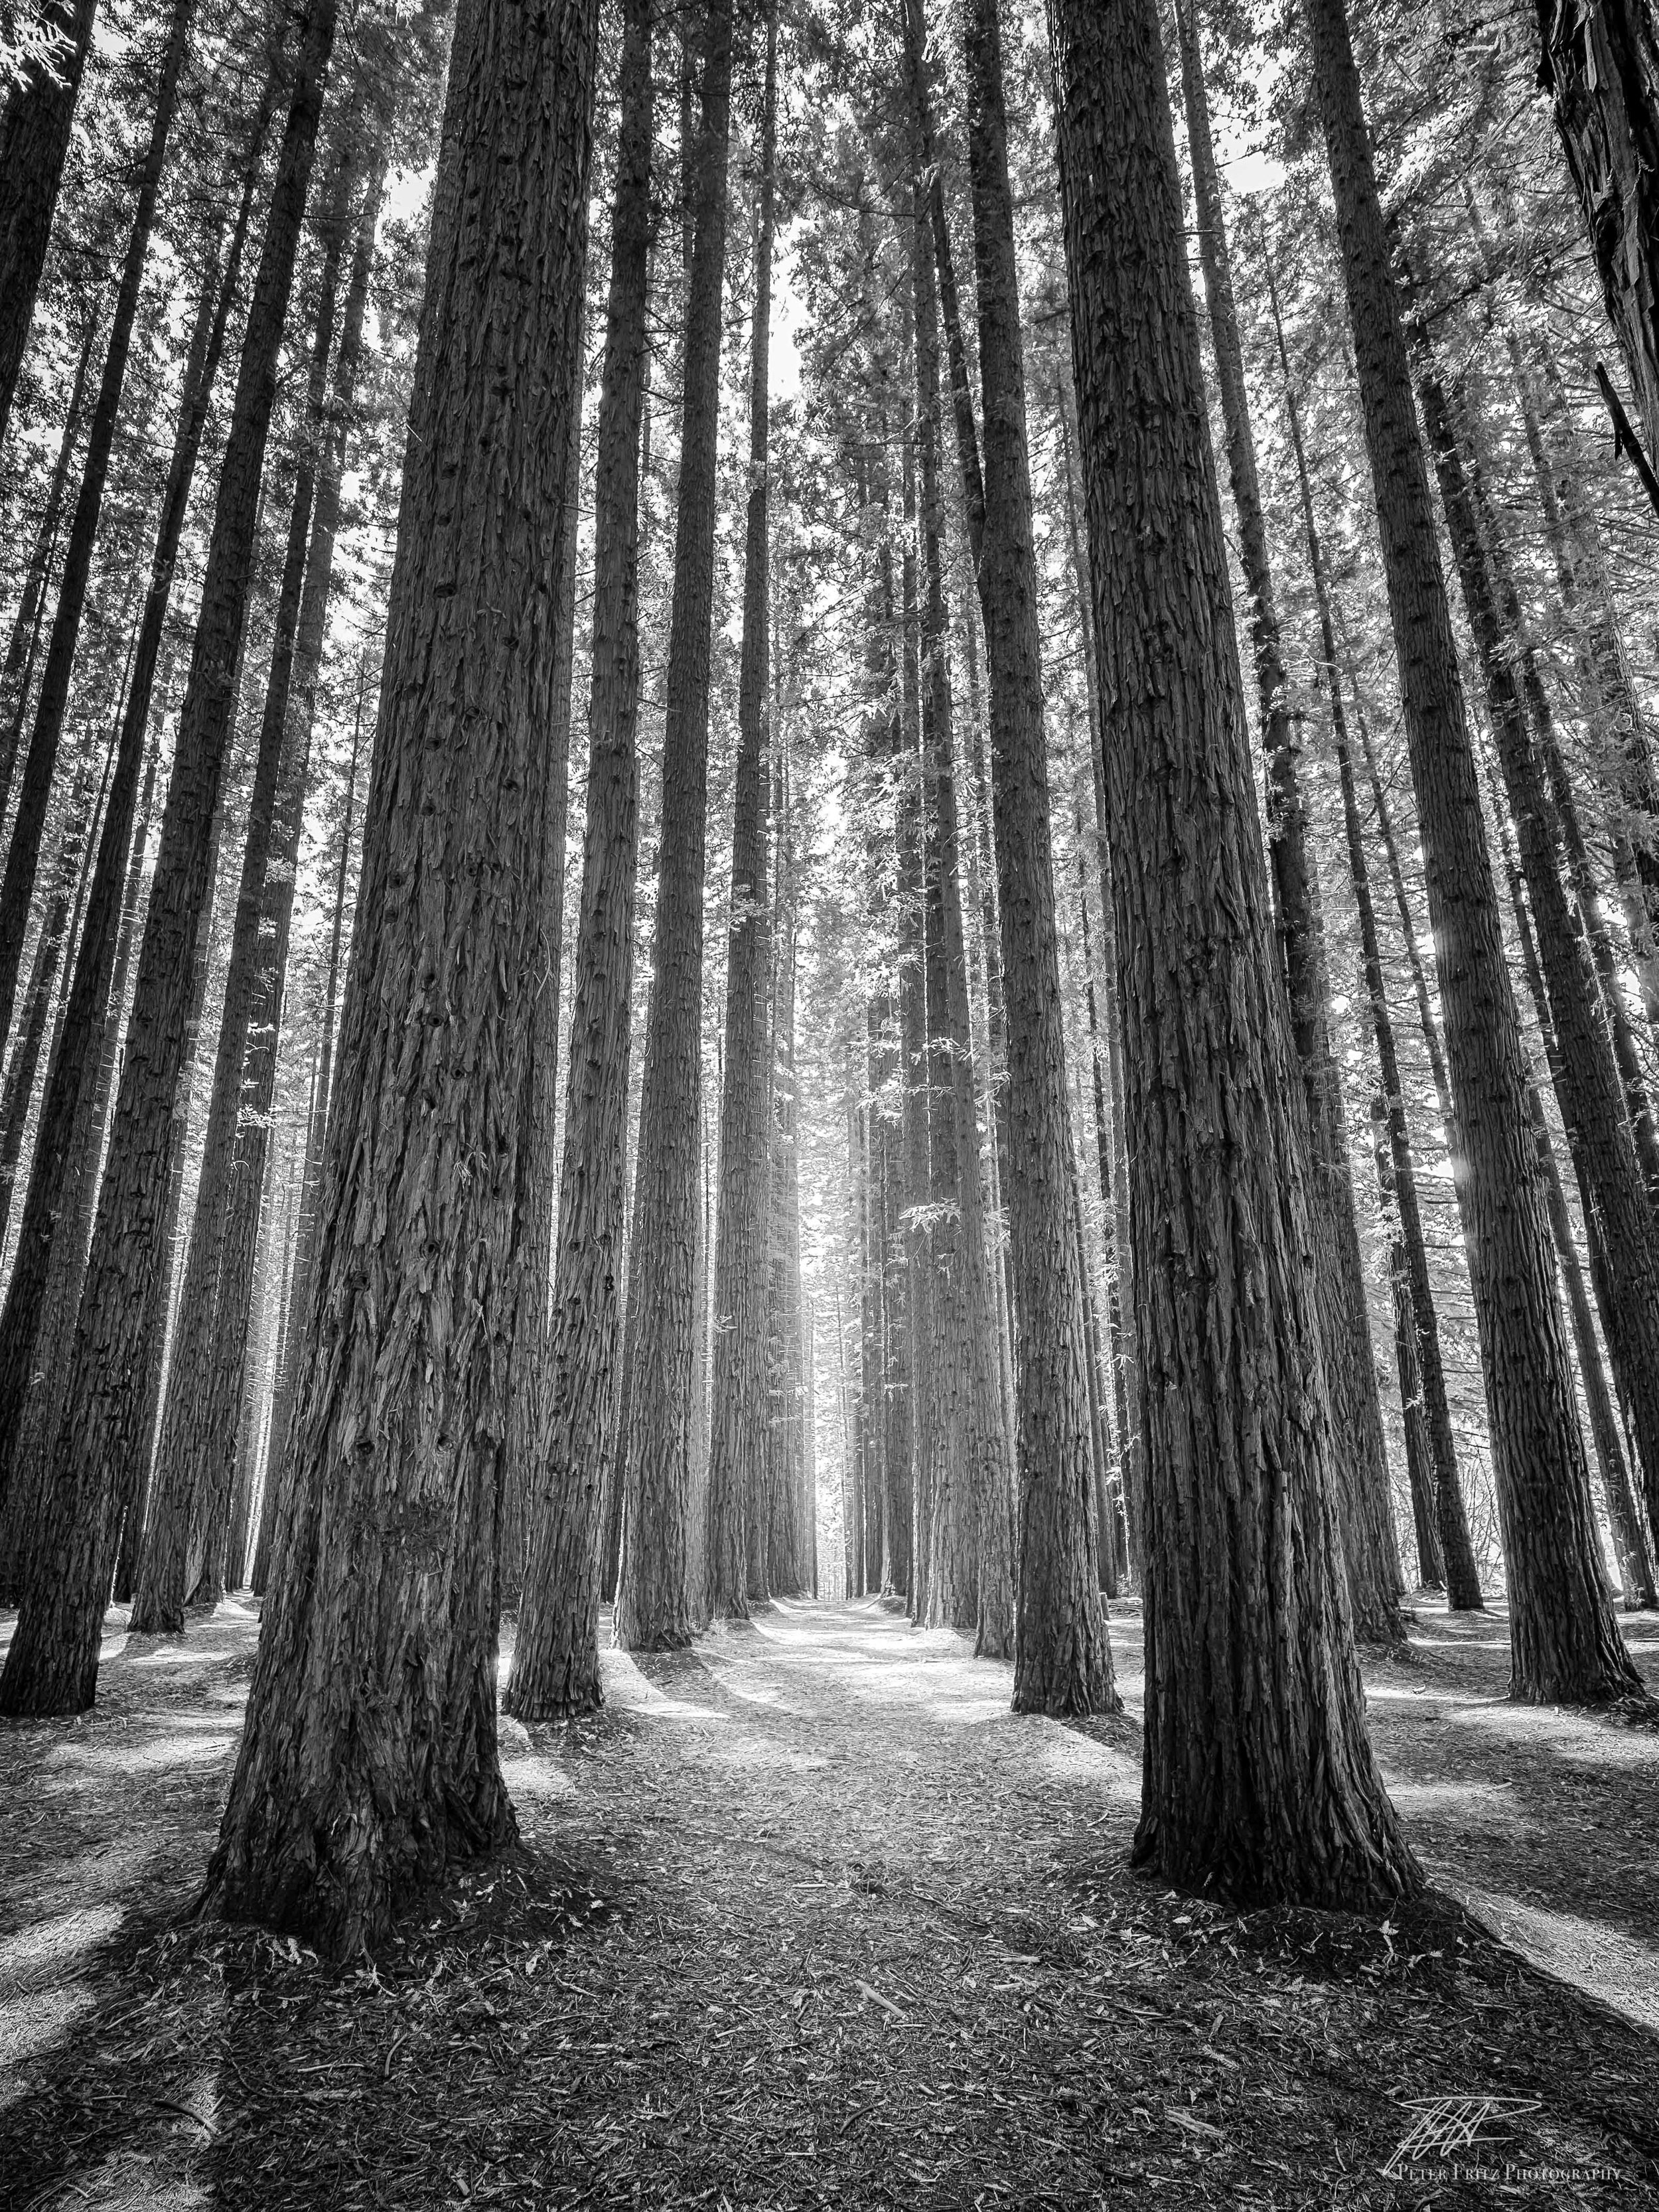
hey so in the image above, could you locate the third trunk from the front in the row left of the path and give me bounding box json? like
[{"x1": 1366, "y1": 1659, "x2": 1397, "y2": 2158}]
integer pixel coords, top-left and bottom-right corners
[{"x1": 615, "y1": 0, "x2": 732, "y2": 1650}]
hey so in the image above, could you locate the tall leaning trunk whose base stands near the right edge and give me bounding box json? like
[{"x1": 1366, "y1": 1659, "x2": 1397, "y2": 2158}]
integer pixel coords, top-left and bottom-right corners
[{"x1": 1303, "y1": 0, "x2": 1634, "y2": 1701}]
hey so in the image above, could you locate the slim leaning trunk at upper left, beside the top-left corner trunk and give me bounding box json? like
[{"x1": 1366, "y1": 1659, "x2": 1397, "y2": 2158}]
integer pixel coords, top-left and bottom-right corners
[{"x1": 0, "y1": 0, "x2": 194, "y2": 1057}]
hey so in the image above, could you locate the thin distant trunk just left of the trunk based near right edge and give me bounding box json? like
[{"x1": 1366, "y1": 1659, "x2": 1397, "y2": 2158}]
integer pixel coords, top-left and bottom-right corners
[{"x1": 1267, "y1": 281, "x2": 1482, "y2": 1613}]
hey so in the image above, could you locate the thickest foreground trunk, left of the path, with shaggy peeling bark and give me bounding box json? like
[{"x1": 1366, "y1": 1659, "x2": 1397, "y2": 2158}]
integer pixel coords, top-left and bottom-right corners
[{"x1": 208, "y1": 0, "x2": 597, "y2": 1958}]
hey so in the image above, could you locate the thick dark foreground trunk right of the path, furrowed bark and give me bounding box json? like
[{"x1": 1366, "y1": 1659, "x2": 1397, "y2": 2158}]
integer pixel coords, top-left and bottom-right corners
[{"x1": 1048, "y1": 0, "x2": 1422, "y2": 1909}]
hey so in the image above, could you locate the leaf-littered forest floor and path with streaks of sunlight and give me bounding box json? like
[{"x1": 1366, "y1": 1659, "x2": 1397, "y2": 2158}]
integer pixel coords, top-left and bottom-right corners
[{"x1": 0, "y1": 1599, "x2": 1659, "y2": 2212}]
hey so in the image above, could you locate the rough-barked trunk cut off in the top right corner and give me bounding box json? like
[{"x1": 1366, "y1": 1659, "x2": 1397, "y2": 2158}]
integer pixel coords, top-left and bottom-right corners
[{"x1": 1535, "y1": 0, "x2": 1659, "y2": 484}]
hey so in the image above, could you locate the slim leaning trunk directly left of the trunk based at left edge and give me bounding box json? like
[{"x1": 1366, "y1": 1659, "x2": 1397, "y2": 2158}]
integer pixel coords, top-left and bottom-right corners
[{"x1": 0, "y1": 99, "x2": 274, "y2": 1539}]
